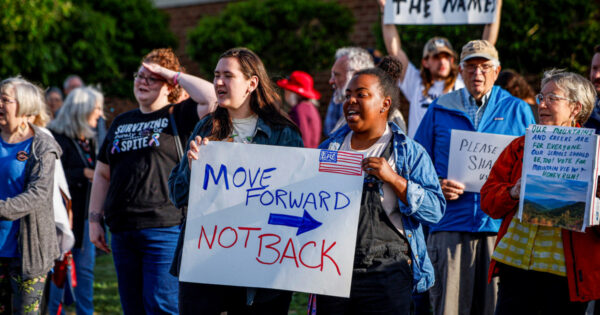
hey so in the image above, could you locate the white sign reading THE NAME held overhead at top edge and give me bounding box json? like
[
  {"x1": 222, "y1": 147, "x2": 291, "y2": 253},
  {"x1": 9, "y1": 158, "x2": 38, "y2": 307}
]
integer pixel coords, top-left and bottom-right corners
[{"x1": 383, "y1": 0, "x2": 496, "y2": 25}]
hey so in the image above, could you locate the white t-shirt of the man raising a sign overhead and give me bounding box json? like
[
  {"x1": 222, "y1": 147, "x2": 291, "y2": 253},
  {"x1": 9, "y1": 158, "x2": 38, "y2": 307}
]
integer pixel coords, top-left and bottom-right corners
[{"x1": 399, "y1": 63, "x2": 465, "y2": 139}]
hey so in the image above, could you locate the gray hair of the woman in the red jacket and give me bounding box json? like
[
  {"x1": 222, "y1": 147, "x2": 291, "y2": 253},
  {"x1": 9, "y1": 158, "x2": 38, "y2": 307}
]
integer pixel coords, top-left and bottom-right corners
[{"x1": 541, "y1": 69, "x2": 596, "y2": 124}]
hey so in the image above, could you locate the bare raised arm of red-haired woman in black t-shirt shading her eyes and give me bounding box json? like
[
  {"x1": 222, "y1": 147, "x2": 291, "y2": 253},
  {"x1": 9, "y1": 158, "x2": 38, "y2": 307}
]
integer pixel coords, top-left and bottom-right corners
[{"x1": 142, "y1": 62, "x2": 217, "y2": 118}]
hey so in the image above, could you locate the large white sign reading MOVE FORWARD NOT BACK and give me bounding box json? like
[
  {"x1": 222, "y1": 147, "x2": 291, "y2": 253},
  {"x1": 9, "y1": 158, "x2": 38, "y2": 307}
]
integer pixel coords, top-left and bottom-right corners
[{"x1": 179, "y1": 142, "x2": 363, "y2": 297}]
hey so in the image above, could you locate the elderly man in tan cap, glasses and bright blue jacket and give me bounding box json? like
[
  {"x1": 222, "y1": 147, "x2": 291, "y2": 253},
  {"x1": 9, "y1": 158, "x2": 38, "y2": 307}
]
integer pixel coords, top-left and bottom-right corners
[{"x1": 415, "y1": 40, "x2": 535, "y2": 315}]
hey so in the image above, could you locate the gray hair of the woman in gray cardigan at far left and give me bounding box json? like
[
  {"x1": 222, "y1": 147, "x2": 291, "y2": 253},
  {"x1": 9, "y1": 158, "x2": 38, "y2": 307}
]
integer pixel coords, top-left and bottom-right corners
[{"x1": 0, "y1": 77, "x2": 50, "y2": 126}]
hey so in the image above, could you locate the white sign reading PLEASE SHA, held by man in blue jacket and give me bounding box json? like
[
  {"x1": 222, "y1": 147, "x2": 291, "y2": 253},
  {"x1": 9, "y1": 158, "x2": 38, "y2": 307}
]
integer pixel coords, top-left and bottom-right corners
[{"x1": 447, "y1": 129, "x2": 516, "y2": 193}]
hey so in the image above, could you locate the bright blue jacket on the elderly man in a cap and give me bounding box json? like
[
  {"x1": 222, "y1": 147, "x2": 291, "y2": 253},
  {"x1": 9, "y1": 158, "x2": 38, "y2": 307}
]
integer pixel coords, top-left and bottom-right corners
[{"x1": 415, "y1": 86, "x2": 535, "y2": 233}]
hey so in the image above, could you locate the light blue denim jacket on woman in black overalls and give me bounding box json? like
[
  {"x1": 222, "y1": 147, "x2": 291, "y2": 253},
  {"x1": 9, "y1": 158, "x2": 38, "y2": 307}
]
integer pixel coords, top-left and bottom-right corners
[{"x1": 319, "y1": 122, "x2": 446, "y2": 292}]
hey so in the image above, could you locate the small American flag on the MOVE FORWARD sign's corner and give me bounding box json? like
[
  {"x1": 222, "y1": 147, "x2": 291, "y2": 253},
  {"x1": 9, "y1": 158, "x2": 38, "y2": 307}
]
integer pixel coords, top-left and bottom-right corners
[{"x1": 319, "y1": 150, "x2": 363, "y2": 176}]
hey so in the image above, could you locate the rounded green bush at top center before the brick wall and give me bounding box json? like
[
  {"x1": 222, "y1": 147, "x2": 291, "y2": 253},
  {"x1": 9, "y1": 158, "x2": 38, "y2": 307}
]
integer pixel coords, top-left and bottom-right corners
[{"x1": 187, "y1": 0, "x2": 354, "y2": 75}]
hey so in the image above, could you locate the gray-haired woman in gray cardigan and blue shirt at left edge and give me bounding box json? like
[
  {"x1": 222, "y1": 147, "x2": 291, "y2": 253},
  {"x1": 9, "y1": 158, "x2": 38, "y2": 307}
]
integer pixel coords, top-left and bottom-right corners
[{"x1": 0, "y1": 78, "x2": 61, "y2": 314}]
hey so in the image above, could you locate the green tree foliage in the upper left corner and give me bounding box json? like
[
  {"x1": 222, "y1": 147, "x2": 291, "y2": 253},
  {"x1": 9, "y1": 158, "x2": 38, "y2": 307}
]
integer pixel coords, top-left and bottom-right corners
[{"x1": 0, "y1": 0, "x2": 176, "y2": 96}]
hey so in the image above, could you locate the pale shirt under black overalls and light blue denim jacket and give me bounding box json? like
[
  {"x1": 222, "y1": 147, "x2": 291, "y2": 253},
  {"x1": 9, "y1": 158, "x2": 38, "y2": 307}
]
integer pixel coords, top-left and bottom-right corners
[{"x1": 340, "y1": 125, "x2": 404, "y2": 234}]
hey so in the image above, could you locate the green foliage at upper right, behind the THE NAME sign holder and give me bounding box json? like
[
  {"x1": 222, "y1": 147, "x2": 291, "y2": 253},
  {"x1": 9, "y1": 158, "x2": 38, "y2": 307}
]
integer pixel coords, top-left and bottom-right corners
[{"x1": 375, "y1": 0, "x2": 600, "y2": 77}]
